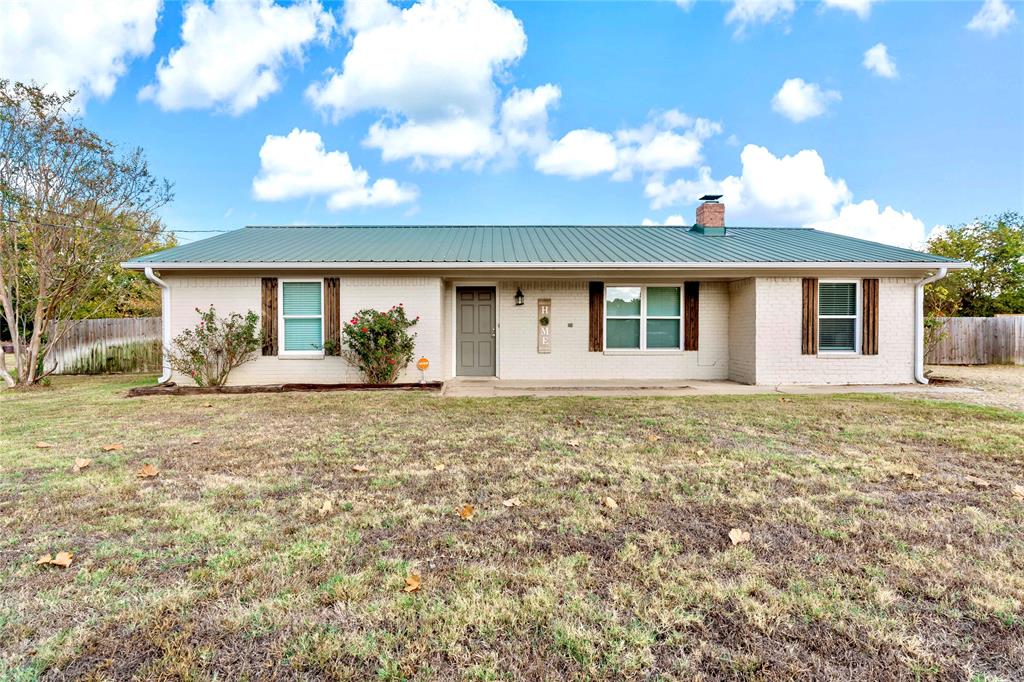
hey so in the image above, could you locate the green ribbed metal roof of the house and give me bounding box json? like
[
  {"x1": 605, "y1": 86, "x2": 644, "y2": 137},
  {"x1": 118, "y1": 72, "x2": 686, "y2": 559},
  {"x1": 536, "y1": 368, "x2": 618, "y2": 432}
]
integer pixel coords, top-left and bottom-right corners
[{"x1": 125, "y1": 225, "x2": 953, "y2": 268}]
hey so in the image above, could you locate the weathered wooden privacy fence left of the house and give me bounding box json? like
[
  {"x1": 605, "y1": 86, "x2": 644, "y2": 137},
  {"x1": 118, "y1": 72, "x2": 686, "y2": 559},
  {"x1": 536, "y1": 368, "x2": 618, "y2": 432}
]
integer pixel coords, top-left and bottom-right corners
[{"x1": 45, "y1": 317, "x2": 161, "y2": 374}]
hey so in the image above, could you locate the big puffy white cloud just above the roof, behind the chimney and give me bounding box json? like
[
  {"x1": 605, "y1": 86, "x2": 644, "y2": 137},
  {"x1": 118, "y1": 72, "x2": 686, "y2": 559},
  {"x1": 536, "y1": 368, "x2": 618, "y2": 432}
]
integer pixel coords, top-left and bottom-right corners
[{"x1": 644, "y1": 144, "x2": 925, "y2": 246}]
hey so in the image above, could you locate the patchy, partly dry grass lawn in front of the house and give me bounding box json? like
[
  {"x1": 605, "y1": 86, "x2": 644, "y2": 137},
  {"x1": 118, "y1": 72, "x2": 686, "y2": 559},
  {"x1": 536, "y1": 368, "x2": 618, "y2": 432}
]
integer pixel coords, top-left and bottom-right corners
[{"x1": 0, "y1": 378, "x2": 1024, "y2": 680}]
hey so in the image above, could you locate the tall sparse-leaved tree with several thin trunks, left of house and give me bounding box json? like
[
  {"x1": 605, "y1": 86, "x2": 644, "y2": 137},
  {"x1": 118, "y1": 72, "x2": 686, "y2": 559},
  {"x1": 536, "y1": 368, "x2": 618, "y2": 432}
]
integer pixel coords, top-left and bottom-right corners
[{"x1": 0, "y1": 79, "x2": 172, "y2": 385}]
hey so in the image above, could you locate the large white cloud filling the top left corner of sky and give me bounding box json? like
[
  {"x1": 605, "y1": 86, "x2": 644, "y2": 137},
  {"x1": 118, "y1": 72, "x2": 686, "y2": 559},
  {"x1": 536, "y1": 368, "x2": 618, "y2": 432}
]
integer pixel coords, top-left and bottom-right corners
[{"x1": 0, "y1": 0, "x2": 160, "y2": 106}]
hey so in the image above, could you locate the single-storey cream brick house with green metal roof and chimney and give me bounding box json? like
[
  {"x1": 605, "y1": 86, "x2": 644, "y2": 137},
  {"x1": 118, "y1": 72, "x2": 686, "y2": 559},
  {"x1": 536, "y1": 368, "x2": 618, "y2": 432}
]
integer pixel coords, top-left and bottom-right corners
[{"x1": 124, "y1": 197, "x2": 966, "y2": 384}]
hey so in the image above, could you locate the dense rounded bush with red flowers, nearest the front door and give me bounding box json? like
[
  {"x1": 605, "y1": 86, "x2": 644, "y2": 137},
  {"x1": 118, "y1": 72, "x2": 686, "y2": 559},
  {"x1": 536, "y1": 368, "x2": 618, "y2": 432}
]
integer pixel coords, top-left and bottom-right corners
[{"x1": 341, "y1": 303, "x2": 420, "y2": 384}]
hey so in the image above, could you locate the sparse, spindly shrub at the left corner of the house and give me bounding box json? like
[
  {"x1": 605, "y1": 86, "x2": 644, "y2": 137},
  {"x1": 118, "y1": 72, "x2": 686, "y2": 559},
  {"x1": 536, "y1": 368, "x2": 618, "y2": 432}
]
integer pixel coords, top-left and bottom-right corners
[{"x1": 170, "y1": 305, "x2": 262, "y2": 386}]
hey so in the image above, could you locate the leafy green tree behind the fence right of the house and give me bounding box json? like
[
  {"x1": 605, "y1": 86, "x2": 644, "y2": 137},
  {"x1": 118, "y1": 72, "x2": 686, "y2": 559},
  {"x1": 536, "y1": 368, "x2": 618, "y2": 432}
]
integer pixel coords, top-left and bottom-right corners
[{"x1": 925, "y1": 211, "x2": 1024, "y2": 317}]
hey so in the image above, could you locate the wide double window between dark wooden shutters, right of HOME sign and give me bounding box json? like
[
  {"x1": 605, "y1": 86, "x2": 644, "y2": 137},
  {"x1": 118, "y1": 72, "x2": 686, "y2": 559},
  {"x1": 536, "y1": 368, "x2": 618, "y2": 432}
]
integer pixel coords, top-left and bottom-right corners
[{"x1": 604, "y1": 287, "x2": 682, "y2": 350}]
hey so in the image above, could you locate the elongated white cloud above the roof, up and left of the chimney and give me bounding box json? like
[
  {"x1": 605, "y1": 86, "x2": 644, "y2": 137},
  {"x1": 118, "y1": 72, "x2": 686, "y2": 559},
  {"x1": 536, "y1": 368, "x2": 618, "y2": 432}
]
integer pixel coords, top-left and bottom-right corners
[{"x1": 537, "y1": 110, "x2": 722, "y2": 180}]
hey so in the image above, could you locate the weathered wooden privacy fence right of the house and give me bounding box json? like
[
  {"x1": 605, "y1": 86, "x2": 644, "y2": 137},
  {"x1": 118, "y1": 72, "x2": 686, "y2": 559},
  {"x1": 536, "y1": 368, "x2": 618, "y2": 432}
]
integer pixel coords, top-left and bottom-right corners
[{"x1": 925, "y1": 315, "x2": 1024, "y2": 365}]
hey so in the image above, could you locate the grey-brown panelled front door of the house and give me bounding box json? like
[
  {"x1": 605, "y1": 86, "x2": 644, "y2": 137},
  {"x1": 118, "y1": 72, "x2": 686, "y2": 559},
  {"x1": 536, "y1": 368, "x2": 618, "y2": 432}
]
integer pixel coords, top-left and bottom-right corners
[{"x1": 455, "y1": 287, "x2": 498, "y2": 377}]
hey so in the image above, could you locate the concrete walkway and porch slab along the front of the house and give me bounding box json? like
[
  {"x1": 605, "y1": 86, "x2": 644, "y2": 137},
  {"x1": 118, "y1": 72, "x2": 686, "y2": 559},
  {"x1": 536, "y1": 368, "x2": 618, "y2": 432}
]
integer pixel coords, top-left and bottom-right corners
[{"x1": 441, "y1": 378, "x2": 981, "y2": 398}]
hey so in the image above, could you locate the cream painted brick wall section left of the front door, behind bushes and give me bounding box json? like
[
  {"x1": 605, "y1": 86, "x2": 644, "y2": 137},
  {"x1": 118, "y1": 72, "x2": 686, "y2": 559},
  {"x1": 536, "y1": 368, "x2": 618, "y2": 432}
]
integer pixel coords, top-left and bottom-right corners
[{"x1": 163, "y1": 272, "x2": 443, "y2": 384}]
